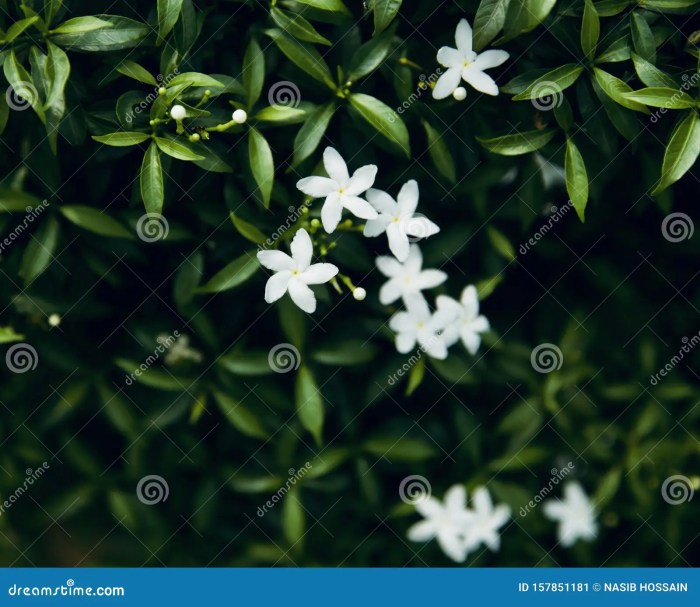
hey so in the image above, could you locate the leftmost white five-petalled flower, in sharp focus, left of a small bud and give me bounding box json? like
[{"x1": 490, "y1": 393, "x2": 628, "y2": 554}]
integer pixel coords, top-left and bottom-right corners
[{"x1": 258, "y1": 229, "x2": 338, "y2": 313}]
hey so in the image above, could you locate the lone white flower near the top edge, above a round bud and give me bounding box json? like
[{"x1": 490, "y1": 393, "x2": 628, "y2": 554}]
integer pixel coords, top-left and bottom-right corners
[{"x1": 433, "y1": 19, "x2": 509, "y2": 99}]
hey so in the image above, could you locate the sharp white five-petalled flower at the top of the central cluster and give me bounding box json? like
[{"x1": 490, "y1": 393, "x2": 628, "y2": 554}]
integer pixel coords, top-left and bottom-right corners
[{"x1": 297, "y1": 148, "x2": 377, "y2": 234}]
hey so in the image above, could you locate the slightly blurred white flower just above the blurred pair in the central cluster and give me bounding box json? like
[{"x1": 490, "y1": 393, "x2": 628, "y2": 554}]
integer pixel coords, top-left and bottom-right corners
[{"x1": 377, "y1": 244, "x2": 447, "y2": 305}]
